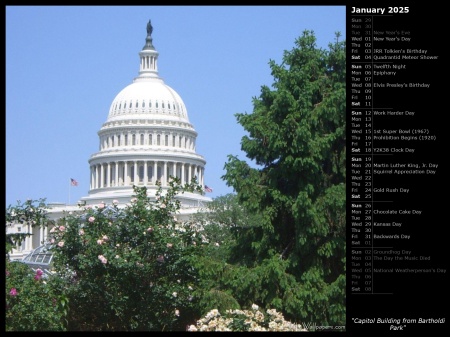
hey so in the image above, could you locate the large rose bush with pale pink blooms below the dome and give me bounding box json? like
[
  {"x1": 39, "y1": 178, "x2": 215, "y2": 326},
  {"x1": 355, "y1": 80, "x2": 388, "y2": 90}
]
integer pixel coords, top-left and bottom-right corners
[{"x1": 48, "y1": 178, "x2": 203, "y2": 331}]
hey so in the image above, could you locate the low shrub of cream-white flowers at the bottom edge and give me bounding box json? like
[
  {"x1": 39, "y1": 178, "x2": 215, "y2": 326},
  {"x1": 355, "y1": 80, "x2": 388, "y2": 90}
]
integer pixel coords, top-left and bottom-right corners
[{"x1": 187, "y1": 304, "x2": 307, "y2": 331}]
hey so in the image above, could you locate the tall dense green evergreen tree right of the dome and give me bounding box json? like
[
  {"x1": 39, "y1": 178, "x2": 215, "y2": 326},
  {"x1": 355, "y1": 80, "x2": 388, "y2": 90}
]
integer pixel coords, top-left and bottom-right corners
[{"x1": 222, "y1": 30, "x2": 346, "y2": 324}]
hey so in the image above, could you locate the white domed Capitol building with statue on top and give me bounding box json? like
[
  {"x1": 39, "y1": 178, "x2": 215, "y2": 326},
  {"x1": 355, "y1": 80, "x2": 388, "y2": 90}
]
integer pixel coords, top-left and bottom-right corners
[{"x1": 7, "y1": 21, "x2": 211, "y2": 259}]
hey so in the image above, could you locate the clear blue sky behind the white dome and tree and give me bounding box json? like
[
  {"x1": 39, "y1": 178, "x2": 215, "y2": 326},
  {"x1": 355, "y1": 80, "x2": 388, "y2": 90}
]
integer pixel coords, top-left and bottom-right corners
[{"x1": 5, "y1": 6, "x2": 345, "y2": 206}]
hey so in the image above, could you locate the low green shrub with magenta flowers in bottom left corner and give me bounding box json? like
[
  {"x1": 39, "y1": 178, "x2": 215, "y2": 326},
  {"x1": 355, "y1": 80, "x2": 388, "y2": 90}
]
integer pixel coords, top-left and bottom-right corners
[{"x1": 5, "y1": 261, "x2": 67, "y2": 331}]
